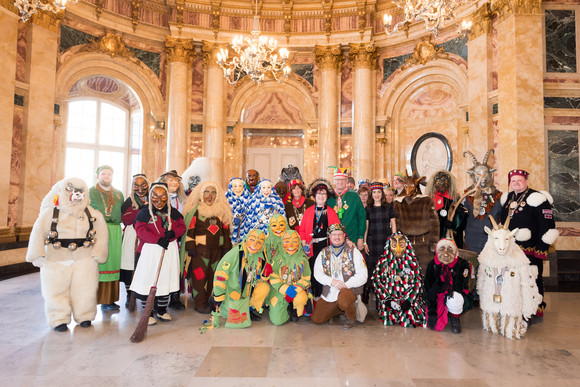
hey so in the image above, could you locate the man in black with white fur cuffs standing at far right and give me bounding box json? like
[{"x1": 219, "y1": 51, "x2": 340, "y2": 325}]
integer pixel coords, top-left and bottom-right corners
[{"x1": 500, "y1": 169, "x2": 559, "y2": 325}]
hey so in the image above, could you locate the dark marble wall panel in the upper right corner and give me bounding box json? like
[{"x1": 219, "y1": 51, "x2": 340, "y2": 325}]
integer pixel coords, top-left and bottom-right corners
[{"x1": 545, "y1": 9, "x2": 576, "y2": 73}]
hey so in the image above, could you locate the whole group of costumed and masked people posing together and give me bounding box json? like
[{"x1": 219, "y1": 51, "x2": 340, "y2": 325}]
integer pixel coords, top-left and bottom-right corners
[{"x1": 27, "y1": 151, "x2": 558, "y2": 337}]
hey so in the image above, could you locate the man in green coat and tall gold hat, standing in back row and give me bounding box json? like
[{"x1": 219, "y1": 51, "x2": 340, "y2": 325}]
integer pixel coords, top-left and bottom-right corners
[{"x1": 328, "y1": 167, "x2": 367, "y2": 250}]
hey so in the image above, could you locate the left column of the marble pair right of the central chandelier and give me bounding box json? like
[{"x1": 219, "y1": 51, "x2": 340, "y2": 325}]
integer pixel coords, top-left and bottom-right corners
[{"x1": 315, "y1": 44, "x2": 344, "y2": 180}]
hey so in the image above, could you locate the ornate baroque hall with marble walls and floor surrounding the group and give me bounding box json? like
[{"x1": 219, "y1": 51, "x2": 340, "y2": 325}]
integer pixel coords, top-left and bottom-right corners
[{"x1": 0, "y1": 0, "x2": 580, "y2": 386}]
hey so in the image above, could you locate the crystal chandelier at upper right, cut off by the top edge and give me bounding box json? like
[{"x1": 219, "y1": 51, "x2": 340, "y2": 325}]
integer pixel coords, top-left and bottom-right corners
[{"x1": 383, "y1": 0, "x2": 479, "y2": 36}]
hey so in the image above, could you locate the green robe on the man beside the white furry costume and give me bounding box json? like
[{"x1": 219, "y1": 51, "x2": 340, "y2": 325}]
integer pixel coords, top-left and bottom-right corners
[{"x1": 89, "y1": 187, "x2": 125, "y2": 282}]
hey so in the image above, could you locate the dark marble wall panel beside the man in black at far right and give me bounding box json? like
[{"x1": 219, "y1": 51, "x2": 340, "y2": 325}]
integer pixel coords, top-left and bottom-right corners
[{"x1": 548, "y1": 130, "x2": 580, "y2": 222}]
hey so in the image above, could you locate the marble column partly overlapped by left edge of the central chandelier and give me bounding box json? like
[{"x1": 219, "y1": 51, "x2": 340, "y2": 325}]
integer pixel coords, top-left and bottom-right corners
[{"x1": 202, "y1": 41, "x2": 226, "y2": 184}]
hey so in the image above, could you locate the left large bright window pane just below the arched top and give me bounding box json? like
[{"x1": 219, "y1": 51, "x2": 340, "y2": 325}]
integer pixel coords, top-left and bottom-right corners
[{"x1": 67, "y1": 100, "x2": 97, "y2": 144}]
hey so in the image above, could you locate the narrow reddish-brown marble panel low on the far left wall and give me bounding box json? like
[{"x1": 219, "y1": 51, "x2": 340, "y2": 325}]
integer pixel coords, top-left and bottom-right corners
[{"x1": 7, "y1": 108, "x2": 24, "y2": 227}]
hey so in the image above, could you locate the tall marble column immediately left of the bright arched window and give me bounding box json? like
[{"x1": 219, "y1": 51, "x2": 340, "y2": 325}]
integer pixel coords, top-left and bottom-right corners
[{"x1": 17, "y1": 12, "x2": 62, "y2": 227}]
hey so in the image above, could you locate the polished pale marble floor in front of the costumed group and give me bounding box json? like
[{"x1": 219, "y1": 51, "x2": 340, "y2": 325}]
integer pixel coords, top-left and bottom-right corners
[{"x1": 0, "y1": 274, "x2": 580, "y2": 387}]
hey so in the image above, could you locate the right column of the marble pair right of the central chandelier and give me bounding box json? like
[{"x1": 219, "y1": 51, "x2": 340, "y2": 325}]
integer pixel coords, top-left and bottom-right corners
[{"x1": 349, "y1": 42, "x2": 377, "y2": 180}]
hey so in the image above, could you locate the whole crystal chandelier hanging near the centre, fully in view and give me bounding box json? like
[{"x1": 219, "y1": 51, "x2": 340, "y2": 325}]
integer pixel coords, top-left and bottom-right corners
[{"x1": 217, "y1": 0, "x2": 292, "y2": 85}]
